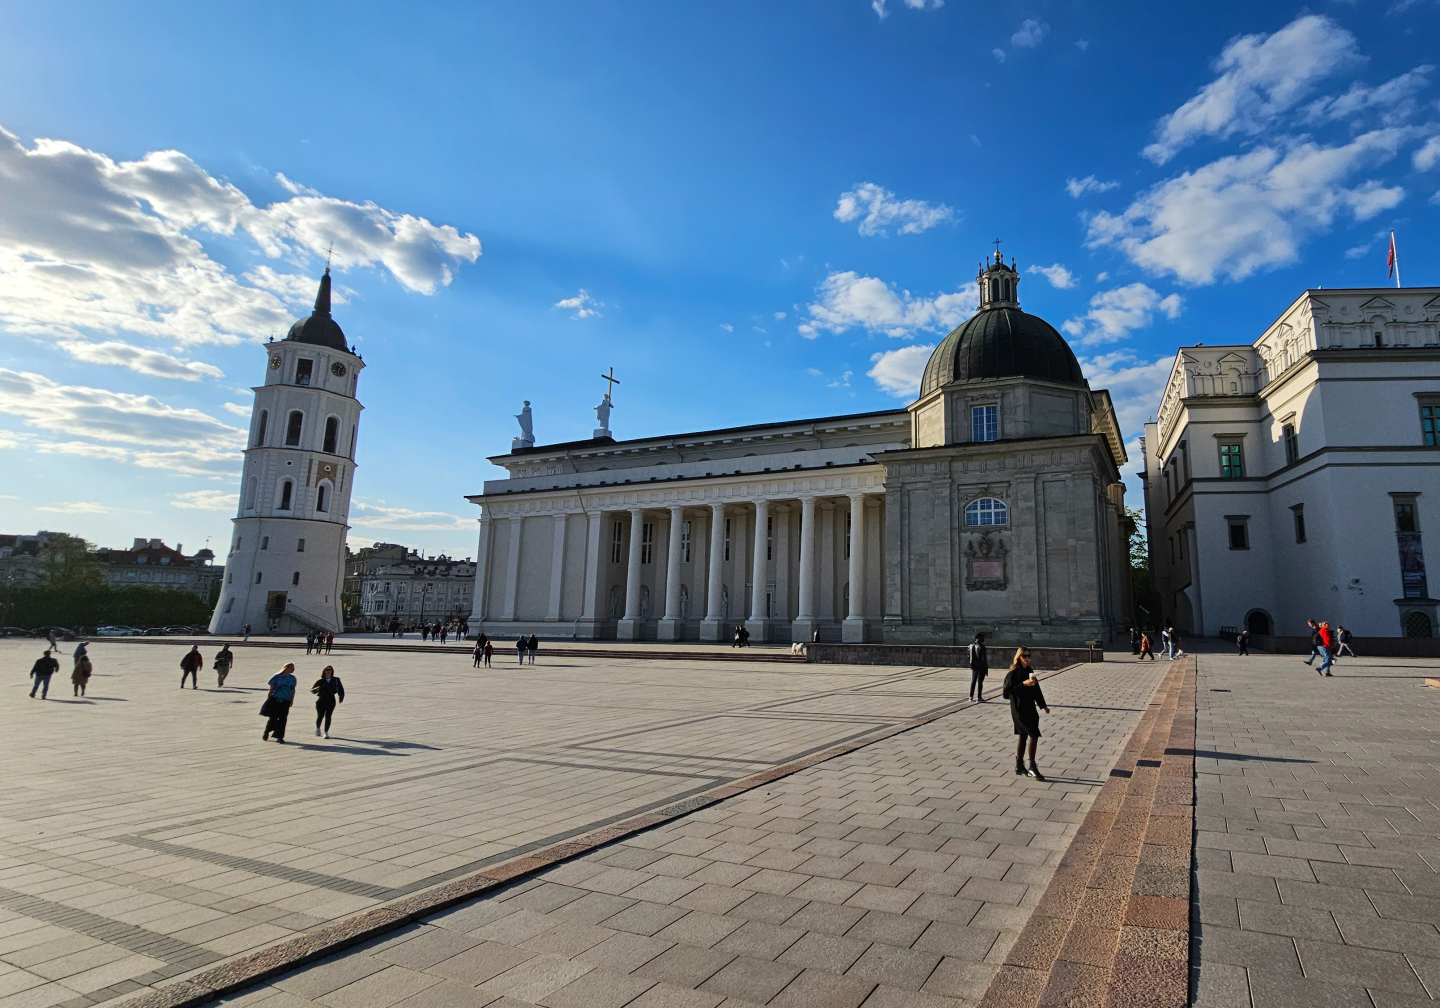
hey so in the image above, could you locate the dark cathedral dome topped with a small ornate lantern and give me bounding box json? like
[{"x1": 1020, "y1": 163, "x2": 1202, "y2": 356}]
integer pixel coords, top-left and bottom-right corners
[{"x1": 920, "y1": 252, "x2": 1086, "y2": 396}]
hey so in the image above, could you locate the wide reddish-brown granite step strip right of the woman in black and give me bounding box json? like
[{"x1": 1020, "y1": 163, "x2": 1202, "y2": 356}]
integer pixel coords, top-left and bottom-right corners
[{"x1": 981, "y1": 658, "x2": 1195, "y2": 1008}]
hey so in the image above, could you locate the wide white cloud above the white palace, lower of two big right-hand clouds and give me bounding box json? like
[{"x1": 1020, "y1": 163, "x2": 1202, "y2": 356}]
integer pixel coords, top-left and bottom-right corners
[{"x1": 1087, "y1": 127, "x2": 1410, "y2": 284}]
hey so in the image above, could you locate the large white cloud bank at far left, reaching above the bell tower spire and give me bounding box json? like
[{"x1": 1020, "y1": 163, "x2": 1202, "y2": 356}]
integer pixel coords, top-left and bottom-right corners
[{"x1": 0, "y1": 128, "x2": 480, "y2": 354}]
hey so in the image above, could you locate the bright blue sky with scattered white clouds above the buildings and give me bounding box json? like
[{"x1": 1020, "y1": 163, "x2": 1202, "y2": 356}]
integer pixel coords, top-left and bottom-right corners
[{"x1": 0, "y1": 0, "x2": 1440, "y2": 556}]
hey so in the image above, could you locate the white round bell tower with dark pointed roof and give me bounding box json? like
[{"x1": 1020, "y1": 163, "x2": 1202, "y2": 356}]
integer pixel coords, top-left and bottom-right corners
[{"x1": 210, "y1": 266, "x2": 364, "y2": 634}]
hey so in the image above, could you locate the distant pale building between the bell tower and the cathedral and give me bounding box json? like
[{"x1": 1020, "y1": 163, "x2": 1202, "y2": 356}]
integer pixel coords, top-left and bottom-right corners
[{"x1": 346, "y1": 543, "x2": 475, "y2": 629}]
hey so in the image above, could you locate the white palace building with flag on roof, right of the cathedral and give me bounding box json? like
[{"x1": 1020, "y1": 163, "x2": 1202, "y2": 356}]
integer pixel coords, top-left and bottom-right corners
[{"x1": 1143, "y1": 287, "x2": 1440, "y2": 638}]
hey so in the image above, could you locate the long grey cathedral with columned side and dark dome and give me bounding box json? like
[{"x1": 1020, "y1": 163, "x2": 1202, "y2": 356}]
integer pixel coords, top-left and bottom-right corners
[{"x1": 468, "y1": 255, "x2": 1132, "y2": 645}]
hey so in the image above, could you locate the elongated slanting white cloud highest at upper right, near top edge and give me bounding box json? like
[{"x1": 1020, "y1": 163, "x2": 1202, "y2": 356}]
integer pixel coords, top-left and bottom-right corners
[{"x1": 1143, "y1": 14, "x2": 1361, "y2": 164}]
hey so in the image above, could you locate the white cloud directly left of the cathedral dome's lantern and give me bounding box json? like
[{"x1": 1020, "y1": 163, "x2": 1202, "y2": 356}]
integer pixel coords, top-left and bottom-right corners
[{"x1": 799, "y1": 271, "x2": 979, "y2": 340}]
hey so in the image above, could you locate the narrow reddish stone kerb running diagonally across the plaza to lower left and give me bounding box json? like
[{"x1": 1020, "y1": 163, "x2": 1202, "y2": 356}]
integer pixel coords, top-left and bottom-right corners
[{"x1": 109, "y1": 662, "x2": 1088, "y2": 1008}]
